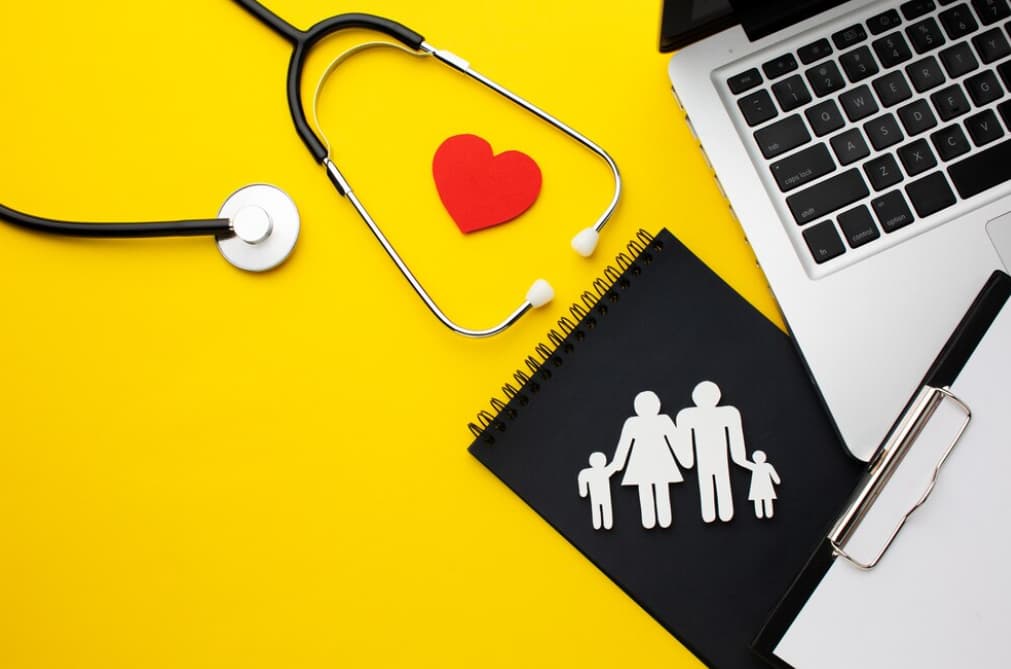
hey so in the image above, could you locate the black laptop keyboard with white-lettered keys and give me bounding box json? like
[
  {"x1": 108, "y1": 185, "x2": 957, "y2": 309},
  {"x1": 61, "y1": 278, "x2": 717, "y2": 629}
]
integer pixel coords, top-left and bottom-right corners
[{"x1": 727, "y1": 0, "x2": 1011, "y2": 264}]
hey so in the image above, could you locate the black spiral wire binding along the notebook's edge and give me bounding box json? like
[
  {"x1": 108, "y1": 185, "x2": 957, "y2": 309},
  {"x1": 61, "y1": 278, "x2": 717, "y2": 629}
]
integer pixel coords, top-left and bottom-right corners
[{"x1": 467, "y1": 228, "x2": 663, "y2": 444}]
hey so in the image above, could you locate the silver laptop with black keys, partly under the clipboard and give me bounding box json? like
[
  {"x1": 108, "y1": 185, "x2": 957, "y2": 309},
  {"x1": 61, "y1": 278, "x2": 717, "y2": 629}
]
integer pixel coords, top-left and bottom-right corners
[{"x1": 661, "y1": 0, "x2": 1011, "y2": 460}]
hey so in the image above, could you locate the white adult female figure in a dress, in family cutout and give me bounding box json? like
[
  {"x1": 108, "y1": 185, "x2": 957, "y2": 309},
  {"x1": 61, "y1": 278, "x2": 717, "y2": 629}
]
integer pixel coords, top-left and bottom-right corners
[{"x1": 609, "y1": 390, "x2": 695, "y2": 530}]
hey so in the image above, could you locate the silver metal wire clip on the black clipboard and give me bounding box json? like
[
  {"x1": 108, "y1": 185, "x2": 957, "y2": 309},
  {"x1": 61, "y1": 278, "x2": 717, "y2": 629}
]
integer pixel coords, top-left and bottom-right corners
[{"x1": 828, "y1": 386, "x2": 973, "y2": 570}]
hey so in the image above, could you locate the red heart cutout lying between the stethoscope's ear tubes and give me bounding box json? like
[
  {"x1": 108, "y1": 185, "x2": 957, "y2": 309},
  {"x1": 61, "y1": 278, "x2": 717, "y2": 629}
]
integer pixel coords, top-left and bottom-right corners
[{"x1": 432, "y1": 134, "x2": 541, "y2": 232}]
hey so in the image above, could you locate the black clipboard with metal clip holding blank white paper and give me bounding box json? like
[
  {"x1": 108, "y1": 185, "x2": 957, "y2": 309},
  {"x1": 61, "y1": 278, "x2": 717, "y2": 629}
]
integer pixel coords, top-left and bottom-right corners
[{"x1": 753, "y1": 272, "x2": 1011, "y2": 669}]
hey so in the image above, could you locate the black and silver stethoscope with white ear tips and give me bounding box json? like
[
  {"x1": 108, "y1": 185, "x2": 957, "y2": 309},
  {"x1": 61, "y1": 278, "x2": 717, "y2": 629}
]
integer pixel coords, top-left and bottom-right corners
[{"x1": 0, "y1": 0, "x2": 622, "y2": 338}]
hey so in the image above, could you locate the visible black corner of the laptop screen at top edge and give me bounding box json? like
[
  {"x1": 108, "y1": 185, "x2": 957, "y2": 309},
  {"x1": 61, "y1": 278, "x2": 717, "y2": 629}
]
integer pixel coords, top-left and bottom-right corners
[{"x1": 660, "y1": 0, "x2": 845, "y2": 52}]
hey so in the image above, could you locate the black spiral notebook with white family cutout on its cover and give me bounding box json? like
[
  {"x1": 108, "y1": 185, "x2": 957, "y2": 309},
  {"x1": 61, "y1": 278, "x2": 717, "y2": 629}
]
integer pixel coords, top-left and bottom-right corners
[{"x1": 470, "y1": 230, "x2": 861, "y2": 668}]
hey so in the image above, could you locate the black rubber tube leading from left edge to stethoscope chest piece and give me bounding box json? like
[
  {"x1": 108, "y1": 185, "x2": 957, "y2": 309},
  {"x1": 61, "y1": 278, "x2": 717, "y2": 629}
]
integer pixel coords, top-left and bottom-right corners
[{"x1": 0, "y1": 204, "x2": 232, "y2": 237}]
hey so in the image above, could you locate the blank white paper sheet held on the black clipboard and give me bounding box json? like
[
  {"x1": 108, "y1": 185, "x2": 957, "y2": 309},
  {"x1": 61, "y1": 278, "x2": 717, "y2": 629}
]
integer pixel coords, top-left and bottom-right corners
[{"x1": 774, "y1": 308, "x2": 1011, "y2": 669}]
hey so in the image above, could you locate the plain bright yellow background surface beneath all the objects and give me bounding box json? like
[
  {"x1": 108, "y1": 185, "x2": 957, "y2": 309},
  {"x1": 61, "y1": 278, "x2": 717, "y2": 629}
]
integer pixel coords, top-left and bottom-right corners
[{"x1": 0, "y1": 0, "x2": 774, "y2": 669}]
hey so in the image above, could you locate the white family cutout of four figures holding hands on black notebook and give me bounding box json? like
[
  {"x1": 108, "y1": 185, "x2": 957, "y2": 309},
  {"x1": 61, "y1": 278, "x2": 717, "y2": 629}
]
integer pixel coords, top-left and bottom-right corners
[{"x1": 578, "y1": 381, "x2": 782, "y2": 530}]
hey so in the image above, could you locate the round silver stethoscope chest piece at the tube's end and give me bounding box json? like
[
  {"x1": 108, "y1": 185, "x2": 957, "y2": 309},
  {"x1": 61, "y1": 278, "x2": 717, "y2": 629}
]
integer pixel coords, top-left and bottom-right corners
[{"x1": 217, "y1": 184, "x2": 299, "y2": 272}]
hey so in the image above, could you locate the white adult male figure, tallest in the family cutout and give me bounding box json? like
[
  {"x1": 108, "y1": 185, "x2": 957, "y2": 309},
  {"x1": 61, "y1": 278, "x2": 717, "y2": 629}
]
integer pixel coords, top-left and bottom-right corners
[{"x1": 676, "y1": 381, "x2": 751, "y2": 522}]
